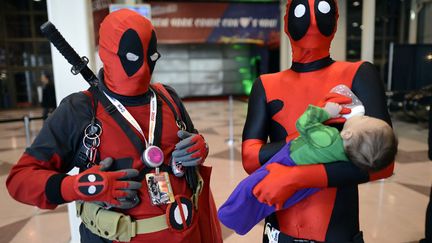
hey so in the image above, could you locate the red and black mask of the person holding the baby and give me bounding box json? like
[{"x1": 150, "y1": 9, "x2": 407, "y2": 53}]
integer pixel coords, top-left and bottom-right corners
[{"x1": 285, "y1": 0, "x2": 339, "y2": 63}]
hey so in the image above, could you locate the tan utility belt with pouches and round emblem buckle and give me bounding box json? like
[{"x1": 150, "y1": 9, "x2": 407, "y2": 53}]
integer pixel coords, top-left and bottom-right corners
[{"x1": 76, "y1": 168, "x2": 204, "y2": 242}]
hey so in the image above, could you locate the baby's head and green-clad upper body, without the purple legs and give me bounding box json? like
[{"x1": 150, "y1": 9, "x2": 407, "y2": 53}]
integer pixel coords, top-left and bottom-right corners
[{"x1": 290, "y1": 102, "x2": 397, "y2": 171}]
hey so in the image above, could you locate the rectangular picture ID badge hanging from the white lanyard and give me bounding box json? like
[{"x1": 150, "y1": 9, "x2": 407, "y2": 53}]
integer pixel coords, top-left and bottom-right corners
[{"x1": 146, "y1": 172, "x2": 174, "y2": 205}]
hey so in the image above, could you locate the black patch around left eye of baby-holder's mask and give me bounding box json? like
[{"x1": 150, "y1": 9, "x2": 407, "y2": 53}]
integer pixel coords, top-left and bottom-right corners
[{"x1": 287, "y1": 0, "x2": 311, "y2": 41}]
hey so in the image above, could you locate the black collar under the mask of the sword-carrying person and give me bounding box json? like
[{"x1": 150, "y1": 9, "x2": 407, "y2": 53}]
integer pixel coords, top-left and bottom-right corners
[{"x1": 98, "y1": 69, "x2": 151, "y2": 106}]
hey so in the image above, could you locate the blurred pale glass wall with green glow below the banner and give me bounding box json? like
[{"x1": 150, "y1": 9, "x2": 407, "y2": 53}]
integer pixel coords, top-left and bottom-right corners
[{"x1": 153, "y1": 44, "x2": 269, "y2": 97}]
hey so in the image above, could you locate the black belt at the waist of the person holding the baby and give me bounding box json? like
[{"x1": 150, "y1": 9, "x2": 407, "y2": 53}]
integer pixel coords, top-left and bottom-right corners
[{"x1": 264, "y1": 223, "x2": 364, "y2": 243}]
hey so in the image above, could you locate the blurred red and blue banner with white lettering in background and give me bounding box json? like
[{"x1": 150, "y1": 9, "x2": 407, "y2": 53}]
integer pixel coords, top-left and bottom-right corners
[{"x1": 150, "y1": 2, "x2": 280, "y2": 45}]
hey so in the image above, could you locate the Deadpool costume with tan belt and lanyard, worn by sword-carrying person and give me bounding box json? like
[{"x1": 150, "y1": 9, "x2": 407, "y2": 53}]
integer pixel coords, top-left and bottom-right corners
[{"x1": 6, "y1": 9, "x2": 222, "y2": 243}]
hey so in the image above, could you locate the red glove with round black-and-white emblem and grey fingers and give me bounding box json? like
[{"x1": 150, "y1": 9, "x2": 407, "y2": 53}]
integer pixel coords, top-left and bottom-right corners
[{"x1": 61, "y1": 158, "x2": 141, "y2": 208}]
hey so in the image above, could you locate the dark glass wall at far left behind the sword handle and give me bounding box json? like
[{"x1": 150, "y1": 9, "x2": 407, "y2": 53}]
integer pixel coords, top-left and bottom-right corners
[{"x1": 0, "y1": 0, "x2": 52, "y2": 108}]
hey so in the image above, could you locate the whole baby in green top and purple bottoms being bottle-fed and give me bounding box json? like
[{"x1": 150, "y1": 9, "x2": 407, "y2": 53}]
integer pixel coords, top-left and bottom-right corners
[{"x1": 218, "y1": 99, "x2": 397, "y2": 235}]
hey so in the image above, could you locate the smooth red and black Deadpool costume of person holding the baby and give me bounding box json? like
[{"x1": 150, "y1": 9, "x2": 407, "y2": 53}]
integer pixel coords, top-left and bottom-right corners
[{"x1": 242, "y1": 0, "x2": 394, "y2": 243}]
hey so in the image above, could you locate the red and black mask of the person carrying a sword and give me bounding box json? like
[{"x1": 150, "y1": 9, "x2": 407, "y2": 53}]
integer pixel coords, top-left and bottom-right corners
[{"x1": 99, "y1": 9, "x2": 160, "y2": 96}]
